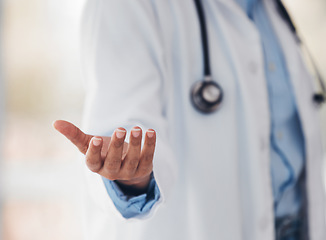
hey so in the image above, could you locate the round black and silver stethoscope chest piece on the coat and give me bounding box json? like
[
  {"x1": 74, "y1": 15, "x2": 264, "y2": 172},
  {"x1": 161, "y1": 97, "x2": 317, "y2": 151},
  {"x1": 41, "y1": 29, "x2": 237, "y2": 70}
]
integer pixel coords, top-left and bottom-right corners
[{"x1": 191, "y1": 78, "x2": 223, "y2": 113}]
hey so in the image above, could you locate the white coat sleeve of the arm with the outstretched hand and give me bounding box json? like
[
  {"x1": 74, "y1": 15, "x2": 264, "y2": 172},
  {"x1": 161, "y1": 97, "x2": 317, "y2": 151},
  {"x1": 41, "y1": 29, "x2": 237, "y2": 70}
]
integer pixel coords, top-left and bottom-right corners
[{"x1": 81, "y1": 0, "x2": 177, "y2": 219}]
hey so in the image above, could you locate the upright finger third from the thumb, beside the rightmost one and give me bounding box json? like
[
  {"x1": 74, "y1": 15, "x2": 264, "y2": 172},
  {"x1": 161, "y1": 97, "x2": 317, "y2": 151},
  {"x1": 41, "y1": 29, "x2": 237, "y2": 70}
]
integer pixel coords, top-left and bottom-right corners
[{"x1": 120, "y1": 127, "x2": 142, "y2": 179}]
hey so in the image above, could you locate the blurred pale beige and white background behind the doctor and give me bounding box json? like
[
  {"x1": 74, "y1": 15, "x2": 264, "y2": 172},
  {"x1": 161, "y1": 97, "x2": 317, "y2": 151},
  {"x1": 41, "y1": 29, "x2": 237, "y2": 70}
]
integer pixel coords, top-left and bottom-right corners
[{"x1": 0, "y1": 0, "x2": 326, "y2": 240}]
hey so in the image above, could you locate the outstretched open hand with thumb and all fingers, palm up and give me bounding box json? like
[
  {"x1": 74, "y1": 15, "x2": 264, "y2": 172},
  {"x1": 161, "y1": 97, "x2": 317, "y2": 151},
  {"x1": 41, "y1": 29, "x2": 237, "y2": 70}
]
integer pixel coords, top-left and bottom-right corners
[{"x1": 53, "y1": 120, "x2": 156, "y2": 194}]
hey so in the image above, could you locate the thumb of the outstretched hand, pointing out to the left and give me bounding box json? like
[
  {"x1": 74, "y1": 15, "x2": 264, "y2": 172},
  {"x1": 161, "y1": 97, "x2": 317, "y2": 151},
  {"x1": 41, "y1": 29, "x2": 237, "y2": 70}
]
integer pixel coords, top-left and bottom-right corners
[{"x1": 53, "y1": 120, "x2": 93, "y2": 154}]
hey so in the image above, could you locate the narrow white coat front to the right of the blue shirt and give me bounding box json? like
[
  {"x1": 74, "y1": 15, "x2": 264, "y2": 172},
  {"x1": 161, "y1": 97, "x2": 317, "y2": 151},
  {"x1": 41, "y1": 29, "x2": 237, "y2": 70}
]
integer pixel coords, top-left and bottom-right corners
[{"x1": 265, "y1": 0, "x2": 326, "y2": 240}]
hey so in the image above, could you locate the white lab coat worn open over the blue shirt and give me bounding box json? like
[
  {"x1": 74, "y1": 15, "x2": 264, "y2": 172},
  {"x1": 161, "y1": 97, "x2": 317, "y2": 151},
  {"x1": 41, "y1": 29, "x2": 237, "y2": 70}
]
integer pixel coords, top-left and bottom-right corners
[{"x1": 82, "y1": 0, "x2": 326, "y2": 240}]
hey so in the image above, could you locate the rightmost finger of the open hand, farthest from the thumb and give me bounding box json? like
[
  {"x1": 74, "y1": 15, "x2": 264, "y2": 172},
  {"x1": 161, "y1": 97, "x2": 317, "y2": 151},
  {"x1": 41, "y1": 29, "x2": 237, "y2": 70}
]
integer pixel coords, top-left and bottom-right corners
[{"x1": 137, "y1": 129, "x2": 156, "y2": 176}]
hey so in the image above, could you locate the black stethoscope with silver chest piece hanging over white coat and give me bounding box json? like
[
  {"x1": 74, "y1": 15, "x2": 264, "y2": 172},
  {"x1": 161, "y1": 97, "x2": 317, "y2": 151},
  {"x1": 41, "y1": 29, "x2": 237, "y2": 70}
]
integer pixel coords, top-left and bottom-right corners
[{"x1": 191, "y1": 0, "x2": 326, "y2": 113}]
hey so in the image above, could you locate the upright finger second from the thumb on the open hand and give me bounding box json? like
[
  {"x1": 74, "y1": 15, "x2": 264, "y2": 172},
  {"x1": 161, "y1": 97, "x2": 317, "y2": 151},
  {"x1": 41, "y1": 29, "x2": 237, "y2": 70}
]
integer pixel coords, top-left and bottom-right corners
[{"x1": 101, "y1": 128, "x2": 126, "y2": 180}]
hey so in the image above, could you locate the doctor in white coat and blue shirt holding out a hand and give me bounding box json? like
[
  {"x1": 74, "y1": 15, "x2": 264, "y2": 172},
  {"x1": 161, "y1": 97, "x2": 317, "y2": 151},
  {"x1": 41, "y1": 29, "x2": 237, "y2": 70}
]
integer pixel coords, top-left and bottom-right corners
[{"x1": 54, "y1": 0, "x2": 326, "y2": 240}]
